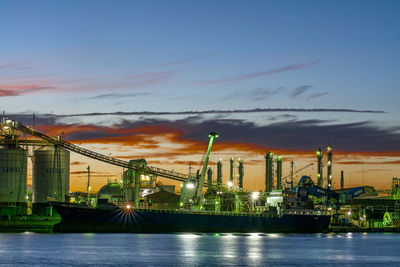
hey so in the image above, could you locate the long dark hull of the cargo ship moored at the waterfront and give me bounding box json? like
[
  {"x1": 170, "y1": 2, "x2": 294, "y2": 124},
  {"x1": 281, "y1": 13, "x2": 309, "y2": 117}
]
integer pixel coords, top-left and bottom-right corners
[{"x1": 52, "y1": 202, "x2": 330, "y2": 233}]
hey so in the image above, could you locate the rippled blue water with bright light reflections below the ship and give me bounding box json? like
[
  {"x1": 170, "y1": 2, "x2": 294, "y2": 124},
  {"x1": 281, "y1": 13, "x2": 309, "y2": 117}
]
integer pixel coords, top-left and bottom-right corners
[{"x1": 0, "y1": 233, "x2": 400, "y2": 266}]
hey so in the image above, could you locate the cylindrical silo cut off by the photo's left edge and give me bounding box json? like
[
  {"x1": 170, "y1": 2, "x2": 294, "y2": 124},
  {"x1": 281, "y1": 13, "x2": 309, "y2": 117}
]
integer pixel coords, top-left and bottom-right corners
[{"x1": 0, "y1": 146, "x2": 27, "y2": 215}]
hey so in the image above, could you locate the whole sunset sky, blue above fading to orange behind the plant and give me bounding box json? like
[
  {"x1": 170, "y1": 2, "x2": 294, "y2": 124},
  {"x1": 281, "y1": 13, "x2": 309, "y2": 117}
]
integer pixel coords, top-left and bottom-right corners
[{"x1": 0, "y1": 0, "x2": 400, "y2": 193}]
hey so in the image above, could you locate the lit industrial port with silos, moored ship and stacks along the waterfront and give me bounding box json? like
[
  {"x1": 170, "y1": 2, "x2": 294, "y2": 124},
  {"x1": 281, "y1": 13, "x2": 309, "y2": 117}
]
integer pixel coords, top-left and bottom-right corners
[{"x1": 0, "y1": 118, "x2": 400, "y2": 232}]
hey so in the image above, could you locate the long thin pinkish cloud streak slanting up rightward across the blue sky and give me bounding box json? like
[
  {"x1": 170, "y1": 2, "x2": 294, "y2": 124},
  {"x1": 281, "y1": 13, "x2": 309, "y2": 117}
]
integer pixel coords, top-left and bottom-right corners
[{"x1": 198, "y1": 60, "x2": 320, "y2": 84}]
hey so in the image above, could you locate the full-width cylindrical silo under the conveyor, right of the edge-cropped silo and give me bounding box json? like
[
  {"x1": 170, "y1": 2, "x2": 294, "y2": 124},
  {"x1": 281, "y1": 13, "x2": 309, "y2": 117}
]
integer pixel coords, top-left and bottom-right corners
[{"x1": 32, "y1": 146, "x2": 70, "y2": 215}]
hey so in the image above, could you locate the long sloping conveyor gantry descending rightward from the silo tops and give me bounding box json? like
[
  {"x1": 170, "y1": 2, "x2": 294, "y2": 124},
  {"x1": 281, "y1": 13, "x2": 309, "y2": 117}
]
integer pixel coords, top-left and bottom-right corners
[{"x1": 2, "y1": 120, "x2": 191, "y2": 184}]
